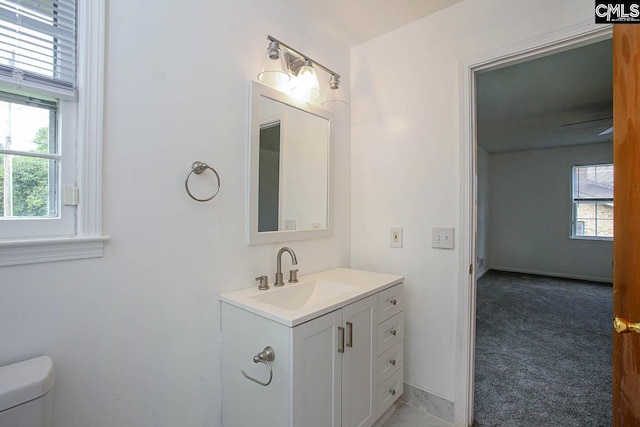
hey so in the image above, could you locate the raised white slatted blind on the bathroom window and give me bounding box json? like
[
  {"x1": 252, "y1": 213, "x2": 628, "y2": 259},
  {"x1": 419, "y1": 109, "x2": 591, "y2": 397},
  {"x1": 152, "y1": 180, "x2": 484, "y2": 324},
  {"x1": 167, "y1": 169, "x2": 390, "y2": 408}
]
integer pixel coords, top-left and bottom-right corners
[{"x1": 0, "y1": 0, "x2": 77, "y2": 98}]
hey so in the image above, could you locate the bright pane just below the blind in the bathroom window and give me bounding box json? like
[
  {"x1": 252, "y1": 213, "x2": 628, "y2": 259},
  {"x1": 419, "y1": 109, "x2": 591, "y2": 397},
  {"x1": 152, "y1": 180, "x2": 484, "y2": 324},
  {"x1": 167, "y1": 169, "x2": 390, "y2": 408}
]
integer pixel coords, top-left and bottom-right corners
[{"x1": 0, "y1": 99, "x2": 57, "y2": 153}]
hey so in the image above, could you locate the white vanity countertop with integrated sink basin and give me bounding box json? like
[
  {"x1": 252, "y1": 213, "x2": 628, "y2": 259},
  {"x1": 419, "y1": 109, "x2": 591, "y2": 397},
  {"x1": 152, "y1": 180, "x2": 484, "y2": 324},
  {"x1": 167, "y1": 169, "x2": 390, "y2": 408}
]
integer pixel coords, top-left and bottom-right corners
[{"x1": 220, "y1": 268, "x2": 404, "y2": 327}]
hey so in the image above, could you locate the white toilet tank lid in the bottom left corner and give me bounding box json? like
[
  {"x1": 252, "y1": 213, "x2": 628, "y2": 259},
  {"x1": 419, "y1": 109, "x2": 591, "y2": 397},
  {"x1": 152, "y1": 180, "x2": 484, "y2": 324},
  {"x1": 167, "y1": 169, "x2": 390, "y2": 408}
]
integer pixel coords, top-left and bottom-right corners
[{"x1": 0, "y1": 356, "x2": 55, "y2": 412}]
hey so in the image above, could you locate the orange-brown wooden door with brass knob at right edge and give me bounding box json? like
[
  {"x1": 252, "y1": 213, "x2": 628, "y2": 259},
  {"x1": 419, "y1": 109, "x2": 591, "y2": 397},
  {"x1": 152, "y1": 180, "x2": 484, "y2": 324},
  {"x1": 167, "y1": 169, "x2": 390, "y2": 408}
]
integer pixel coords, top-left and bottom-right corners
[{"x1": 613, "y1": 24, "x2": 640, "y2": 427}]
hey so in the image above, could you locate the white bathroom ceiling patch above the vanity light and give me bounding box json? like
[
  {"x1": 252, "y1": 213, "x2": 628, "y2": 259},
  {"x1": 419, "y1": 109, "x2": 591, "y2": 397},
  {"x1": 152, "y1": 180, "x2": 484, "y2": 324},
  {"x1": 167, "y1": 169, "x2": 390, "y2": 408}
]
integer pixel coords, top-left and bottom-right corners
[{"x1": 285, "y1": 0, "x2": 462, "y2": 47}]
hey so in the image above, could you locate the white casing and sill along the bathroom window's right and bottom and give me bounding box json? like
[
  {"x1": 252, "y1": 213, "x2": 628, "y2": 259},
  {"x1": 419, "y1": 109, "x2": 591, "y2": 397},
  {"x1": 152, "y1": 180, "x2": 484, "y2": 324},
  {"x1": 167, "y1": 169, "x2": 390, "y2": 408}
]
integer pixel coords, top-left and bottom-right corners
[{"x1": 0, "y1": 0, "x2": 109, "y2": 266}]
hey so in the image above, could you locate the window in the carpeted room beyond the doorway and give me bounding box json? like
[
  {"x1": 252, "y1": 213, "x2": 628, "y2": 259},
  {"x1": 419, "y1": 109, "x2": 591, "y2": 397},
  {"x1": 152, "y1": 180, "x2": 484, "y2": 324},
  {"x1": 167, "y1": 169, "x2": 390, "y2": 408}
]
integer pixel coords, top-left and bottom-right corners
[{"x1": 572, "y1": 164, "x2": 613, "y2": 240}]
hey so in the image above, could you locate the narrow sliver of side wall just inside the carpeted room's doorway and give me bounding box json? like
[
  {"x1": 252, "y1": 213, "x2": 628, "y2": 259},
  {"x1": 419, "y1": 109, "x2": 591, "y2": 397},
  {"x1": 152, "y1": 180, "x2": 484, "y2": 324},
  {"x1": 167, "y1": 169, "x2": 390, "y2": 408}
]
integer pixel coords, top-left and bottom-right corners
[{"x1": 476, "y1": 147, "x2": 491, "y2": 276}]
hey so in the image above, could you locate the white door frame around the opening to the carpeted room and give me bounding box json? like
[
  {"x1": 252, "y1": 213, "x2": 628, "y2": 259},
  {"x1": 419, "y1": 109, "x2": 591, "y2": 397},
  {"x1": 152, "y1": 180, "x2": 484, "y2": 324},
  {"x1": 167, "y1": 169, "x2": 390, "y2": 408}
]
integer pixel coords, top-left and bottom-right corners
[{"x1": 454, "y1": 20, "x2": 613, "y2": 426}]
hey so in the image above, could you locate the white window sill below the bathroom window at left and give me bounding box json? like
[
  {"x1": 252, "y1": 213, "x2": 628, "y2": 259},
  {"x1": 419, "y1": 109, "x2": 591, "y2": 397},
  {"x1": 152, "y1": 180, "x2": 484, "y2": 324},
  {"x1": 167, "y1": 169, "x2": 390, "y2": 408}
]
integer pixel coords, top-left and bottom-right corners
[{"x1": 0, "y1": 236, "x2": 109, "y2": 267}]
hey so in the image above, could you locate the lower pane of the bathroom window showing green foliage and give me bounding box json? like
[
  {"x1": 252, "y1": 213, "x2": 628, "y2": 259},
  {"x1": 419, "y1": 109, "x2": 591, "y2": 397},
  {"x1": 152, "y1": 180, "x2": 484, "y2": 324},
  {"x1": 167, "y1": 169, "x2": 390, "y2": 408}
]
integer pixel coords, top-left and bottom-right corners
[{"x1": 2, "y1": 155, "x2": 57, "y2": 218}]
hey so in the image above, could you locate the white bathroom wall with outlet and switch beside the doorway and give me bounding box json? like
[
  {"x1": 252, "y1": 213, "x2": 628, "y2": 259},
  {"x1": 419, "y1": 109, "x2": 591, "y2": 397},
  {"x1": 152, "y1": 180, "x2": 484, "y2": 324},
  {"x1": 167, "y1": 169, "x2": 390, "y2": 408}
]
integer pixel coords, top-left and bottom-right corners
[{"x1": 351, "y1": 0, "x2": 593, "y2": 401}]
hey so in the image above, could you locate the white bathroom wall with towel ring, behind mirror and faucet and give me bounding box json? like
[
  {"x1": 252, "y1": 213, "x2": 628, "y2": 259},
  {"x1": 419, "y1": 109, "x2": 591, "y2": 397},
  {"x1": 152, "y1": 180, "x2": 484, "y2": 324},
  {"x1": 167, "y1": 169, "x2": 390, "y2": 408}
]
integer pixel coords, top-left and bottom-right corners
[{"x1": 0, "y1": 0, "x2": 350, "y2": 427}]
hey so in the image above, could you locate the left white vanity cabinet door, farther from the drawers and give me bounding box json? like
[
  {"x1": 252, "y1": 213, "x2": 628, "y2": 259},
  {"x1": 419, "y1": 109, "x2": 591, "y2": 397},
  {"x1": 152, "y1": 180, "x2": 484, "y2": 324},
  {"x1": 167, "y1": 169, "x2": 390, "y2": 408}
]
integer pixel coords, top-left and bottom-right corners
[{"x1": 291, "y1": 310, "x2": 342, "y2": 427}]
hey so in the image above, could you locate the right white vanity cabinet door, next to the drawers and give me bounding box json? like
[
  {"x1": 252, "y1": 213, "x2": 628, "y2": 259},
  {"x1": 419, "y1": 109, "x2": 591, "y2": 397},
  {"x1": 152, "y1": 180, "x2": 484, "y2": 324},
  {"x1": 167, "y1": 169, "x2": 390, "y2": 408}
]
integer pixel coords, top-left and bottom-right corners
[{"x1": 342, "y1": 295, "x2": 378, "y2": 427}]
